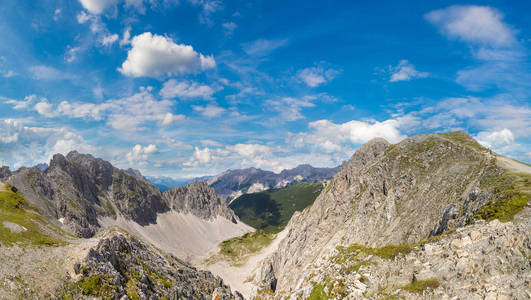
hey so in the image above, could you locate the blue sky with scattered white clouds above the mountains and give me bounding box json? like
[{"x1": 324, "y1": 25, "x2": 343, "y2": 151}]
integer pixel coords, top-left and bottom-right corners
[{"x1": 0, "y1": 0, "x2": 531, "y2": 178}]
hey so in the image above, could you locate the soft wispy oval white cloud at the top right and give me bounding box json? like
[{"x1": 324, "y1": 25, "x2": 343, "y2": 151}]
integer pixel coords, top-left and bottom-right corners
[{"x1": 425, "y1": 5, "x2": 515, "y2": 46}]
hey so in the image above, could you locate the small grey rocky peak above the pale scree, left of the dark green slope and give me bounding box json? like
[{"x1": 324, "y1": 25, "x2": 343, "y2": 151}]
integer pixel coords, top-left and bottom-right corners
[{"x1": 163, "y1": 181, "x2": 237, "y2": 223}]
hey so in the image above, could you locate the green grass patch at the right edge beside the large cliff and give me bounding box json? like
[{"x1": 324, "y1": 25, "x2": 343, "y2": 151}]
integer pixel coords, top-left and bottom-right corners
[{"x1": 474, "y1": 173, "x2": 531, "y2": 222}]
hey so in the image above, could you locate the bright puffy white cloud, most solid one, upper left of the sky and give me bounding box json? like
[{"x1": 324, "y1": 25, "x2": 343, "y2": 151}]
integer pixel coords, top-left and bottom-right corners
[{"x1": 118, "y1": 32, "x2": 215, "y2": 77}]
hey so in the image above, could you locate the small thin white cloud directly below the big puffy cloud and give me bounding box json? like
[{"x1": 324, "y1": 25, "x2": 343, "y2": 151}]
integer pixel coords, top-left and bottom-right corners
[{"x1": 160, "y1": 79, "x2": 216, "y2": 100}]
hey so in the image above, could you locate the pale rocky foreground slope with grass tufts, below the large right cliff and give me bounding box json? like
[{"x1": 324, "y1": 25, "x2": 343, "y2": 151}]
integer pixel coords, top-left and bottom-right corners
[{"x1": 291, "y1": 220, "x2": 531, "y2": 300}]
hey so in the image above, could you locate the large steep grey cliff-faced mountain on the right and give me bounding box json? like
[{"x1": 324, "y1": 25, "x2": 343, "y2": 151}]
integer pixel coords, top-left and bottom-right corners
[{"x1": 257, "y1": 132, "x2": 528, "y2": 294}]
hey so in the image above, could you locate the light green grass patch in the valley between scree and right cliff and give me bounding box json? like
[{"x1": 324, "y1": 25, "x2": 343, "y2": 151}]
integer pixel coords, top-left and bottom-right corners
[{"x1": 205, "y1": 230, "x2": 275, "y2": 266}]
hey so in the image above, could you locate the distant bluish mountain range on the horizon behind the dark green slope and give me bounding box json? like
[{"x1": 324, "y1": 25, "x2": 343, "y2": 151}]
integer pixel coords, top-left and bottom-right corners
[{"x1": 208, "y1": 165, "x2": 338, "y2": 200}]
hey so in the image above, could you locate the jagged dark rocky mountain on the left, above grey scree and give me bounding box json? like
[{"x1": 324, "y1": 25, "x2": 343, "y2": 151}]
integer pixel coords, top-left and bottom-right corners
[{"x1": 7, "y1": 151, "x2": 169, "y2": 237}]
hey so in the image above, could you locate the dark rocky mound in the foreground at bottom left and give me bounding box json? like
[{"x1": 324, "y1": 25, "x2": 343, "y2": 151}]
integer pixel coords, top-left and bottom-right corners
[{"x1": 71, "y1": 231, "x2": 243, "y2": 300}]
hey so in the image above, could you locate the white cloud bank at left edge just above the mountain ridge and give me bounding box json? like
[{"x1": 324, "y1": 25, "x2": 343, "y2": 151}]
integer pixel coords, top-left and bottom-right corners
[{"x1": 0, "y1": 119, "x2": 96, "y2": 168}]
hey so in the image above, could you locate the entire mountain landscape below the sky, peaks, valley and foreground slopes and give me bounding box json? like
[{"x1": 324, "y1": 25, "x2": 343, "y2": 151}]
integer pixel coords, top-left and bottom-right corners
[{"x1": 0, "y1": 131, "x2": 531, "y2": 299}]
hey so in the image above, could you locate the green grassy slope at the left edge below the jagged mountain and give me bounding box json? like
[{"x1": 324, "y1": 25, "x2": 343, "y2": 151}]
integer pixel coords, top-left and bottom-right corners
[{"x1": 0, "y1": 188, "x2": 65, "y2": 246}]
